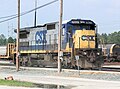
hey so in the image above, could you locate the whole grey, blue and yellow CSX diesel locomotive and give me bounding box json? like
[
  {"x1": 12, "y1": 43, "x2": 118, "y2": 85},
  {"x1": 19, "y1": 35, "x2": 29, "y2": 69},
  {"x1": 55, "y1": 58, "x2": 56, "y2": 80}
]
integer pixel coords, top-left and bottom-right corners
[{"x1": 14, "y1": 19, "x2": 103, "y2": 68}]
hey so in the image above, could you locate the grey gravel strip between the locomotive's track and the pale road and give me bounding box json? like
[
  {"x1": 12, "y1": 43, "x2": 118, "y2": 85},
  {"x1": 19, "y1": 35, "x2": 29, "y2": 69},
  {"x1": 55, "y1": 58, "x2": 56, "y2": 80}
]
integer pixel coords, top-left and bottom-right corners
[{"x1": 0, "y1": 67, "x2": 120, "y2": 81}]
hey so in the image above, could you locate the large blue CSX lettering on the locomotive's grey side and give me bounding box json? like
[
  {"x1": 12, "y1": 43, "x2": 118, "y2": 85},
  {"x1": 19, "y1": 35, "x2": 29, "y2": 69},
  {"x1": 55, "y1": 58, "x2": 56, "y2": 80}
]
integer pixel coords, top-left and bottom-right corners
[{"x1": 35, "y1": 30, "x2": 47, "y2": 44}]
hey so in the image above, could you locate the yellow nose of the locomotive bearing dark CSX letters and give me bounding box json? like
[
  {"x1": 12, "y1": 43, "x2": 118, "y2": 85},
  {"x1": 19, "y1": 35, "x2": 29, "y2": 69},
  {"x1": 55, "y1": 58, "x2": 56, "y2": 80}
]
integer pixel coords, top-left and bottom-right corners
[{"x1": 74, "y1": 30, "x2": 95, "y2": 48}]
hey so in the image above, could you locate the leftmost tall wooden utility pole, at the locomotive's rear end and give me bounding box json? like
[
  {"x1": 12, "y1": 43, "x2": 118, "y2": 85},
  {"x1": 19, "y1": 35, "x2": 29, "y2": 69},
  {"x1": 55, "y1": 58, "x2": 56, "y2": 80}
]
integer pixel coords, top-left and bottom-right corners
[{"x1": 16, "y1": 0, "x2": 20, "y2": 71}]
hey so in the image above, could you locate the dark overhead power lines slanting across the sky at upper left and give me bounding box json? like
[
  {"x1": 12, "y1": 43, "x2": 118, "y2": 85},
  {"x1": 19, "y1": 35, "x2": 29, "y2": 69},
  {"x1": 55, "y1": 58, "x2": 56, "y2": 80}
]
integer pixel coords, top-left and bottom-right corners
[{"x1": 0, "y1": 0, "x2": 59, "y2": 23}]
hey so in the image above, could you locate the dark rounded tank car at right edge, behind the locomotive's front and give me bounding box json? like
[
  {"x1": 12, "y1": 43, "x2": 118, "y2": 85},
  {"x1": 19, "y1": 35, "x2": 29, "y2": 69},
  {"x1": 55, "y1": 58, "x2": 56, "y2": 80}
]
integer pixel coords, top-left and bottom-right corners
[{"x1": 103, "y1": 44, "x2": 120, "y2": 62}]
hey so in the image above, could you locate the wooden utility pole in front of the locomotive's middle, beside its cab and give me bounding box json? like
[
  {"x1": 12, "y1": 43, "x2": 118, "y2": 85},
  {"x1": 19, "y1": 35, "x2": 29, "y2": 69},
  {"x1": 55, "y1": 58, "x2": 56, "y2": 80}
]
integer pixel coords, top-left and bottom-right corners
[{"x1": 58, "y1": 0, "x2": 63, "y2": 73}]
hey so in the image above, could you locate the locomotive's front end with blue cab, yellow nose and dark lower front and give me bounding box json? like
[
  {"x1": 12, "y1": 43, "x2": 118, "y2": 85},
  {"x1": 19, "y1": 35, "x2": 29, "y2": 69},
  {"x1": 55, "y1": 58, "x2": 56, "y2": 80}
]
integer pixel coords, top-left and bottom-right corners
[{"x1": 63, "y1": 19, "x2": 103, "y2": 68}]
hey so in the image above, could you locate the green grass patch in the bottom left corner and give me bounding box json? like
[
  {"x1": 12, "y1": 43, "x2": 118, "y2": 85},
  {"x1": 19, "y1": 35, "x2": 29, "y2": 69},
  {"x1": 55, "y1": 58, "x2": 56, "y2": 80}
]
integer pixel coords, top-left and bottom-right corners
[{"x1": 0, "y1": 79, "x2": 37, "y2": 87}]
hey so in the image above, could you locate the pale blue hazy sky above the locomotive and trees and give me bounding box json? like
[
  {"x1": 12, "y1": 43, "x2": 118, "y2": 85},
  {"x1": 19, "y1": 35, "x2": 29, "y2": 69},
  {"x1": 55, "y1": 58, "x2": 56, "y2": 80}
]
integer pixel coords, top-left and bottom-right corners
[{"x1": 0, "y1": 0, "x2": 120, "y2": 36}]
